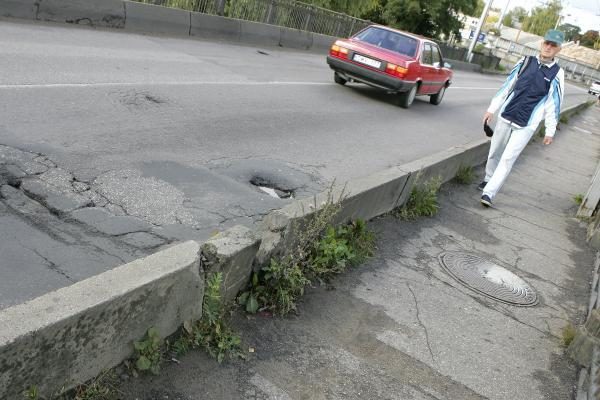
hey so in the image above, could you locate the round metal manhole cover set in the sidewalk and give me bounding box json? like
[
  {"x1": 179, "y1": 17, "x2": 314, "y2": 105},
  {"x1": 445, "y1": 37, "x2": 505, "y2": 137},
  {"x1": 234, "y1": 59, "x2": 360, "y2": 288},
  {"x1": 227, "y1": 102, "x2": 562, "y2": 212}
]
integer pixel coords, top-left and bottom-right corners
[{"x1": 439, "y1": 252, "x2": 537, "y2": 306}]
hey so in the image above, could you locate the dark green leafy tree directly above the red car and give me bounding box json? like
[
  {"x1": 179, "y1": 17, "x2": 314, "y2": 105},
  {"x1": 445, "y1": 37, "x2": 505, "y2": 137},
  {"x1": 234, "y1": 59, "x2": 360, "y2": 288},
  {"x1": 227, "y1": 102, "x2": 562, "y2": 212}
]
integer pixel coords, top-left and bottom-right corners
[{"x1": 382, "y1": 0, "x2": 477, "y2": 37}]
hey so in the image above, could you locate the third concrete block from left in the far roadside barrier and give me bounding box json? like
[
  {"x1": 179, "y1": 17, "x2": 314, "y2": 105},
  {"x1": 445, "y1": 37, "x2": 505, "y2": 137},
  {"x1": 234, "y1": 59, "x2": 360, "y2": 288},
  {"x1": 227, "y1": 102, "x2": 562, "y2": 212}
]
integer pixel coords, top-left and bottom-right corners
[{"x1": 124, "y1": 1, "x2": 191, "y2": 36}]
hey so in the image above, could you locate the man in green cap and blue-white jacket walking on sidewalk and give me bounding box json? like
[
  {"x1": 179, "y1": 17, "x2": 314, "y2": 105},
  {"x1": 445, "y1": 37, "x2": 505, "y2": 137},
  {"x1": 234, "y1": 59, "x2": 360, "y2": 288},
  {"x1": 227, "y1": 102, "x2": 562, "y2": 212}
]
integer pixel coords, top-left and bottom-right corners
[{"x1": 479, "y1": 29, "x2": 565, "y2": 207}]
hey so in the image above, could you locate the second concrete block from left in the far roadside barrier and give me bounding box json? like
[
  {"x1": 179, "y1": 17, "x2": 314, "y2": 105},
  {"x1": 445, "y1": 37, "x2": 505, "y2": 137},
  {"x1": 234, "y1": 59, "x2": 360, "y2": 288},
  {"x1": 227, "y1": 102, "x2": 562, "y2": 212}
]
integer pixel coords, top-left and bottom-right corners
[{"x1": 36, "y1": 0, "x2": 125, "y2": 28}]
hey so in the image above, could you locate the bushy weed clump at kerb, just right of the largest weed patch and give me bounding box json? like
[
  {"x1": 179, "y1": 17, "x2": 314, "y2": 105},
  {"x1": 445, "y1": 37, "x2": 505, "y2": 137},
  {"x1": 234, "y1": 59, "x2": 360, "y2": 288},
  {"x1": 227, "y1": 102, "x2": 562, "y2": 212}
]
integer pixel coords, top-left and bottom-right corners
[{"x1": 392, "y1": 176, "x2": 442, "y2": 221}]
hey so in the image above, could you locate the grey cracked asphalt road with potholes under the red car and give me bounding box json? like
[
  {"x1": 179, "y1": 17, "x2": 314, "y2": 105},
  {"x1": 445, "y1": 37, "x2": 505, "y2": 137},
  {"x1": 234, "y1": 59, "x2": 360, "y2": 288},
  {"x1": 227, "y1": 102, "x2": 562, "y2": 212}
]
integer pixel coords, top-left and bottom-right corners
[{"x1": 0, "y1": 20, "x2": 587, "y2": 308}]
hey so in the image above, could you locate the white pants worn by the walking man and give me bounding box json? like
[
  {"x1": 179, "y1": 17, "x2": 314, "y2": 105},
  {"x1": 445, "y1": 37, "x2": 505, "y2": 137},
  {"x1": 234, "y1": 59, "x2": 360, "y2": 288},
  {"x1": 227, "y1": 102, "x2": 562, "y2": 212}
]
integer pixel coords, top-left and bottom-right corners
[{"x1": 483, "y1": 119, "x2": 535, "y2": 199}]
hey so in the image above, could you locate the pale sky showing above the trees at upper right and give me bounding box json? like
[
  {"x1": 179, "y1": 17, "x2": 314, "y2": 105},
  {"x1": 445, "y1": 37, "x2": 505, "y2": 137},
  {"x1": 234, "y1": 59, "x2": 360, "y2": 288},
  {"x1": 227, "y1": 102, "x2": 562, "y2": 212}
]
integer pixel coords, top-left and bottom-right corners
[{"x1": 492, "y1": 0, "x2": 600, "y2": 32}]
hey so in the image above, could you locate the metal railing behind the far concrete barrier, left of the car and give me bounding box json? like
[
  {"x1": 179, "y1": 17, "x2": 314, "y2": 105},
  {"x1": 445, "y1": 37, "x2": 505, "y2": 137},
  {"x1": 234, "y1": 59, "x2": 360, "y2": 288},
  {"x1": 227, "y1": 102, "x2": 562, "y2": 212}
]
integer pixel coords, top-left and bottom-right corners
[{"x1": 134, "y1": 0, "x2": 371, "y2": 37}]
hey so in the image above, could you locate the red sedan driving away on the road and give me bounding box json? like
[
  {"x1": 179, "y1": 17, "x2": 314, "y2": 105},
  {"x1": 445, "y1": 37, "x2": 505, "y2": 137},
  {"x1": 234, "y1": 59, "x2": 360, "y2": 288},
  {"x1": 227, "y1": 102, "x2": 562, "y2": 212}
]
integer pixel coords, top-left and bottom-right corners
[{"x1": 327, "y1": 25, "x2": 452, "y2": 108}]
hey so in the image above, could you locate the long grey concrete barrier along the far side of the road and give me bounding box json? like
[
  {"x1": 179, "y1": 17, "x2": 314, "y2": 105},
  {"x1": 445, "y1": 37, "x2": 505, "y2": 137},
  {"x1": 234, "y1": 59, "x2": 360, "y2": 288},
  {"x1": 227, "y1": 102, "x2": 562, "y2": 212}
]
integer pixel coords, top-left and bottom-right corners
[{"x1": 0, "y1": 0, "x2": 481, "y2": 71}]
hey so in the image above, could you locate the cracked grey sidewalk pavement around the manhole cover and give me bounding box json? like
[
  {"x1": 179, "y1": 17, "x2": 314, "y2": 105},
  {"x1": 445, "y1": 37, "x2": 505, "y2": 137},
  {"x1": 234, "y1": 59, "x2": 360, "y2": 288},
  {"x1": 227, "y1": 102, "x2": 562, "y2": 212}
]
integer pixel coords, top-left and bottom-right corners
[{"x1": 120, "y1": 107, "x2": 600, "y2": 400}]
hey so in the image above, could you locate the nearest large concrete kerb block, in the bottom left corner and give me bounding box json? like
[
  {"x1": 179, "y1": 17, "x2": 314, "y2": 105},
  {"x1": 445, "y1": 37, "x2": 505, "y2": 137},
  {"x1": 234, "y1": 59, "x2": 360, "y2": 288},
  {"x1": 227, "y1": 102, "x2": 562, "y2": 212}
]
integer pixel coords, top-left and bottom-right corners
[{"x1": 0, "y1": 242, "x2": 204, "y2": 399}]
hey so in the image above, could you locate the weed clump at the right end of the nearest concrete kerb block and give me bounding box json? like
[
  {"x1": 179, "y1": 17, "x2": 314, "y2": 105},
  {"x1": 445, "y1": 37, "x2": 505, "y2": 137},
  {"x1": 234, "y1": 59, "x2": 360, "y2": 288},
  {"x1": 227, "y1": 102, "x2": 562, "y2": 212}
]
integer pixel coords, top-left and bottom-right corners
[{"x1": 178, "y1": 272, "x2": 243, "y2": 363}]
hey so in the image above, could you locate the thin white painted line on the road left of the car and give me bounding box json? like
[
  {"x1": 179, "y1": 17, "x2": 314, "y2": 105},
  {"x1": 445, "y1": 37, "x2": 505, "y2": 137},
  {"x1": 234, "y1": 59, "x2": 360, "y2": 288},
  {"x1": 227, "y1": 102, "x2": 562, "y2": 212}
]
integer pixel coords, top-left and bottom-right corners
[{"x1": 0, "y1": 81, "x2": 333, "y2": 89}]
